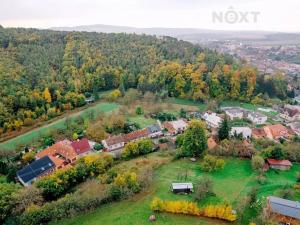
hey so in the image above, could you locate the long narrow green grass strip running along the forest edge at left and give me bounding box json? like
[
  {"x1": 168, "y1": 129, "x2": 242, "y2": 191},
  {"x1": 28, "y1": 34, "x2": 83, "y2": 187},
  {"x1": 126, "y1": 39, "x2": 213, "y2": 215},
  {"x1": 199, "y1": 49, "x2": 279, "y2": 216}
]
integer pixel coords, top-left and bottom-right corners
[{"x1": 0, "y1": 102, "x2": 119, "y2": 150}]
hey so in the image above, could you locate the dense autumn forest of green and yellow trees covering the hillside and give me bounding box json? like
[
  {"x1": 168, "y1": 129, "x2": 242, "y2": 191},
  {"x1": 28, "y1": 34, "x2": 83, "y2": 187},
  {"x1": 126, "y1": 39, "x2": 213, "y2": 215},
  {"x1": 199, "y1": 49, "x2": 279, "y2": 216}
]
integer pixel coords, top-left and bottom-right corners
[{"x1": 0, "y1": 26, "x2": 287, "y2": 135}]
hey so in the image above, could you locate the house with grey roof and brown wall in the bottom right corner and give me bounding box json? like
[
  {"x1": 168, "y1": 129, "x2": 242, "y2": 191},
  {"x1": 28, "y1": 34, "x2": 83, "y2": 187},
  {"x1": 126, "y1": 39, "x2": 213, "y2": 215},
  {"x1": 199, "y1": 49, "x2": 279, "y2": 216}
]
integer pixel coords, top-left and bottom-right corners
[{"x1": 264, "y1": 196, "x2": 300, "y2": 225}]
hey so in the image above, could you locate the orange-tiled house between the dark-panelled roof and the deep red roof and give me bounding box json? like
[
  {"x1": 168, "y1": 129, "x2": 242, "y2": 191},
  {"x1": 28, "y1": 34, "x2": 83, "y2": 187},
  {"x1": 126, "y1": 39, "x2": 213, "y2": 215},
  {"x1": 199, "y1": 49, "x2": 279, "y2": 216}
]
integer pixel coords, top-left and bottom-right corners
[{"x1": 35, "y1": 140, "x2": 78, "y2": 163}]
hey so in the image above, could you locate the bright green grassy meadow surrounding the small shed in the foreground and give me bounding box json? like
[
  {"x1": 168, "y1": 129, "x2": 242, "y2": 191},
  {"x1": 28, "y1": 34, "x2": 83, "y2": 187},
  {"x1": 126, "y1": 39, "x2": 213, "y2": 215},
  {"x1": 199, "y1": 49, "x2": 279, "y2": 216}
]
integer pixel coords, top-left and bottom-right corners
[{"x1": 53, "y1": 159, "x2": 300, "y2": 225}]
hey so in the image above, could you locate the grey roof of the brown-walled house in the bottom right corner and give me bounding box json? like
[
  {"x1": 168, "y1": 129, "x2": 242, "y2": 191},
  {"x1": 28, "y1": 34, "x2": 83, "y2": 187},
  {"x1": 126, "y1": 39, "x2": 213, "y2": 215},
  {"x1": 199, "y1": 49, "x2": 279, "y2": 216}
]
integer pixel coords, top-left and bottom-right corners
[{"x1": 269, "y1": 196, "x2": 300, "y2": 219}]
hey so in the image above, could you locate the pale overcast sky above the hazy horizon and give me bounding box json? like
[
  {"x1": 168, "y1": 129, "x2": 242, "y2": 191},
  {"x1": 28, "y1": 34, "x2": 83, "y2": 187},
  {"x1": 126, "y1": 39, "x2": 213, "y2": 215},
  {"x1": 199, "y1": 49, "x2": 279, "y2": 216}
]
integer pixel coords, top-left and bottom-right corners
[{"x1": 0, "y1": 0, "x2": 300, "y2": 32}]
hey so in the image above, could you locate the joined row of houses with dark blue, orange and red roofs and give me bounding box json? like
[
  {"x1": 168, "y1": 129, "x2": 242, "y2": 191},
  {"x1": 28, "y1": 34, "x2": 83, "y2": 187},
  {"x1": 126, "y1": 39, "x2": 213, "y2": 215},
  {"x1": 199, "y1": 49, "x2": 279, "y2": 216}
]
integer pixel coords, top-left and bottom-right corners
[{"x1": 17, "y1": 138, "x2": 93, "y2": 186}]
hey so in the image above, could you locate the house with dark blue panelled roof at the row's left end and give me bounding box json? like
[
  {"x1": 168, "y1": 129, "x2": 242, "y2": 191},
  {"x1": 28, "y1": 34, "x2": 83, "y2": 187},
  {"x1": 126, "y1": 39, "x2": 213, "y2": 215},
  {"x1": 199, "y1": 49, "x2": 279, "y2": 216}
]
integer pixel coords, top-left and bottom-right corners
[{"x1": 17, "y1": 156, "x2": 55, "y2": 186}]
